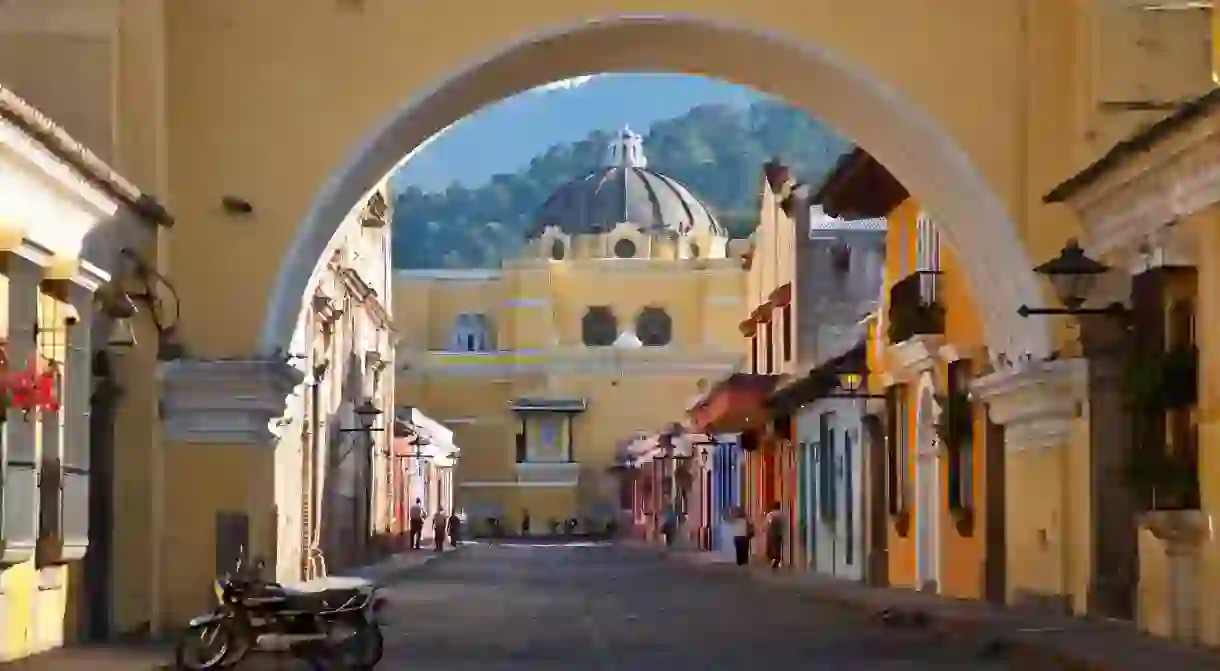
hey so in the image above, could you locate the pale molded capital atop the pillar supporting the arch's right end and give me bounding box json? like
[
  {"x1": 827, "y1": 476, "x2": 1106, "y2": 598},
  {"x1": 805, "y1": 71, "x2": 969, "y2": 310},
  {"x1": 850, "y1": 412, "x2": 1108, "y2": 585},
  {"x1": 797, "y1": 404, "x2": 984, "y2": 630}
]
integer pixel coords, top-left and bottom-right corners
[{"x1": 970, "y1": 359, "x2": 1088, "y2": 451}]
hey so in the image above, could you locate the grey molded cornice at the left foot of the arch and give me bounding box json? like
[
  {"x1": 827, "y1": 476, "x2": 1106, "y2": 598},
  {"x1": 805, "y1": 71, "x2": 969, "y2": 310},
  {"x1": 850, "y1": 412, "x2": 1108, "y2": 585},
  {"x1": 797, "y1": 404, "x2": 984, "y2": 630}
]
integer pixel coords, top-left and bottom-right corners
[{"x1": 157, "y1": 359, "x2": 305, "y2": 445}]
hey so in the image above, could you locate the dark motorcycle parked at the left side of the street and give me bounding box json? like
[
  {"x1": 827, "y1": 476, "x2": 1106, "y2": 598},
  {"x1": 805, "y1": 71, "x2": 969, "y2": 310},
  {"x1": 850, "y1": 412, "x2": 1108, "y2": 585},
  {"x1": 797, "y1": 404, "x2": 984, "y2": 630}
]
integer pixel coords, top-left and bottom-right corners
[{"x1": 176, "y1": 561, "x2": 386, "y2": 671}]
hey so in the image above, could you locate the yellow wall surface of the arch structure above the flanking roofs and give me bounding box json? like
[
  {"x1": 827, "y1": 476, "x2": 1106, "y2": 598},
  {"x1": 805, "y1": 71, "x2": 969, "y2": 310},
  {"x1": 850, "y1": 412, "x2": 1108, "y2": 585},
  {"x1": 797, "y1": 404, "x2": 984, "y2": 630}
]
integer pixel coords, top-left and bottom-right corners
[{"x1": 7, "y1": 0, "x2": 1210, "y2": 363}]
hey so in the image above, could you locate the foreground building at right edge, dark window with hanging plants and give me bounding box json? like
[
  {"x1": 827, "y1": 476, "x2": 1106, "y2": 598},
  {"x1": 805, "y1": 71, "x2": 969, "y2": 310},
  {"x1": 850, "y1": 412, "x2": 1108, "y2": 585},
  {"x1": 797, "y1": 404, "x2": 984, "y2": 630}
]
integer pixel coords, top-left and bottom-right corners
[{"x1": 1047, "y1": 87, "x2": 1220, "y2": 645}]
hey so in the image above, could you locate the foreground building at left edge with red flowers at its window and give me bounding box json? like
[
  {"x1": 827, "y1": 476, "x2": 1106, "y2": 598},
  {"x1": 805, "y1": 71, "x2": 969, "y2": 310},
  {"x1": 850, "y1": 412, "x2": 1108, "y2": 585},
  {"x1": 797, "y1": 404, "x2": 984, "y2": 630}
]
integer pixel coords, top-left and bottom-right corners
[{"x1": 0, "y1": 87, "x2": 172, "y2": 661}]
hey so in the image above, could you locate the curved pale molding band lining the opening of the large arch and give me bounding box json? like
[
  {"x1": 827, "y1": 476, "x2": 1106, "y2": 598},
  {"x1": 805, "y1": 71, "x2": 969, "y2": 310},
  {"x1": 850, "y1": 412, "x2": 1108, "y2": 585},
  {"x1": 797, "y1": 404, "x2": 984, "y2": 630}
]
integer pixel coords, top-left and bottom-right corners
[{"x1": 259, "y1": 15, "x2": 1052, "y2": 357}]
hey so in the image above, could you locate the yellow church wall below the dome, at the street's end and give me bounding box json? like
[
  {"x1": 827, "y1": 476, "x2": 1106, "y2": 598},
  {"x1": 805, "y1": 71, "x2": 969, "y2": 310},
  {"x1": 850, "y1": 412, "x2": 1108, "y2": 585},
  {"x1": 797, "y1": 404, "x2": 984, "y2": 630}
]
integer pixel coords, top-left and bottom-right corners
[{"x1": 394, "y1": 259, "x2": 745, "y2": 529}]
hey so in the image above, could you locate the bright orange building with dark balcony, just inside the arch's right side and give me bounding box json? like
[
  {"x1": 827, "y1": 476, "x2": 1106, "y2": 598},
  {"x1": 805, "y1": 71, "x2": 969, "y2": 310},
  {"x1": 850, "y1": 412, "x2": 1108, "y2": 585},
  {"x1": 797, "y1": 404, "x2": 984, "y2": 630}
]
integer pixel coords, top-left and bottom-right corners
[{"x1": 824, "y1": 150, "x2": 1004, "y2": 601}]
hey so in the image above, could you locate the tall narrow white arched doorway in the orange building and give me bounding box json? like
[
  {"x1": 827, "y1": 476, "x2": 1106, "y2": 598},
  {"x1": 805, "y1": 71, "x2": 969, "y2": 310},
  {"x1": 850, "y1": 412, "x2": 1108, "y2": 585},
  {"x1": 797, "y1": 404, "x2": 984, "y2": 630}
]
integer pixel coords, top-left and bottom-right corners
[{"x1": 914, "y1": 372, "x2": 941, "y2": 592}]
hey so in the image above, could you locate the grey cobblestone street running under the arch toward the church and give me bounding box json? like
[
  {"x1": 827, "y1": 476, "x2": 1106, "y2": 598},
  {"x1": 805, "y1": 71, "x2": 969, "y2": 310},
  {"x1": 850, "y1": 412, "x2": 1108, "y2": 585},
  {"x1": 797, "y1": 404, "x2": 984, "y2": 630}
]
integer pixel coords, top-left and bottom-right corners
[{"x1": 383, "y1": 543, "x2": 1013, "y2": 671}]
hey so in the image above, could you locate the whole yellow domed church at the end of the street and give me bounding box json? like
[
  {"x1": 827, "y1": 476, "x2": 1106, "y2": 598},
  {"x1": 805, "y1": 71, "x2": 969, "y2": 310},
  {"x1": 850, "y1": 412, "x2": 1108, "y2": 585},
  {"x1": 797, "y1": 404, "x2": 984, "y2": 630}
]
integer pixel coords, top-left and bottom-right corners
[{"x1": 394, "y1": 129, "x2": 745, "y2": 533}]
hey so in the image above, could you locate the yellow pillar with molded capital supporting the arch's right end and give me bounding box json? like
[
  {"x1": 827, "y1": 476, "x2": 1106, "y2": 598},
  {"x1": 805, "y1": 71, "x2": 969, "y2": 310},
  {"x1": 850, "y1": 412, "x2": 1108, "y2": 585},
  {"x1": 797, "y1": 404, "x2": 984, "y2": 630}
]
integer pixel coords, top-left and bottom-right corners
[{"x1": 971, "y1": 359, "x2": 1089, "y2": 610}]
